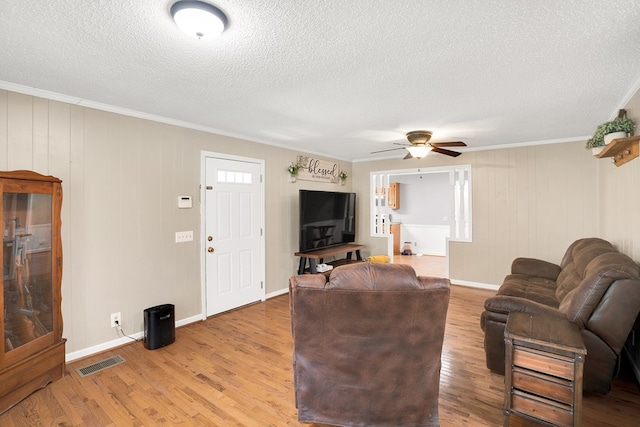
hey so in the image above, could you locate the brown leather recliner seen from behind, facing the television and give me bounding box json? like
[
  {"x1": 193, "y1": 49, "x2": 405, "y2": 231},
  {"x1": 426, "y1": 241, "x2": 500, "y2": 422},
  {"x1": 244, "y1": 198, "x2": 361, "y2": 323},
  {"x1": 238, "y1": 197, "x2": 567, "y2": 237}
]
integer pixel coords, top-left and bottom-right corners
[{"x1": 289, "y1": 262, "x2": 450, "y2": 426}]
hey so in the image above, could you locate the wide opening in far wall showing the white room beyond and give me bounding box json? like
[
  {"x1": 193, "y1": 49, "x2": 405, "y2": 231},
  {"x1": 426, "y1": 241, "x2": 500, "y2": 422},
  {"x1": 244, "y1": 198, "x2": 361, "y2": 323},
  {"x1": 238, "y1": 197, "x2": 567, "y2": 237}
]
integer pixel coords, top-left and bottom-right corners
[{"x1": 370, "y1": 165, "x2": 472, "y2": 275}]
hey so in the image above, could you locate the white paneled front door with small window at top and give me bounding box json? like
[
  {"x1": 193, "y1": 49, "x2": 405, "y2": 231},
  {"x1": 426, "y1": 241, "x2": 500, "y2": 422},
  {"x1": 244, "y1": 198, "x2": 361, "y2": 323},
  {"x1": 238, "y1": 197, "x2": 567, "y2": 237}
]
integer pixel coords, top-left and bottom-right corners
[{"x1": 204, "y1": 157, "x2": 265, "y2": 316}]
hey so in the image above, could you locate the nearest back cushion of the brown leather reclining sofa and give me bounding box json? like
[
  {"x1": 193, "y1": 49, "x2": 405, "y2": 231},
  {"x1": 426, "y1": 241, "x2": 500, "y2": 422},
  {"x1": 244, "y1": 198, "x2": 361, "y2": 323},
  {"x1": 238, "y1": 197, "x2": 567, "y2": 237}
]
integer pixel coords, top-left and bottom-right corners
[{"x1": 558, "y1": 252, "x2": 640, "y2": 329}]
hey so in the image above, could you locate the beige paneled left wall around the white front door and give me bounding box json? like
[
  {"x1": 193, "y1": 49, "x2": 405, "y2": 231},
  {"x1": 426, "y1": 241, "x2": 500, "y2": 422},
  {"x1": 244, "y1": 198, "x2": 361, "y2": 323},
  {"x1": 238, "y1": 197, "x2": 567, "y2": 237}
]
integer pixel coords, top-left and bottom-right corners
[{"x1": 0, "y1": 90, "x2": 352, "y2": 355}]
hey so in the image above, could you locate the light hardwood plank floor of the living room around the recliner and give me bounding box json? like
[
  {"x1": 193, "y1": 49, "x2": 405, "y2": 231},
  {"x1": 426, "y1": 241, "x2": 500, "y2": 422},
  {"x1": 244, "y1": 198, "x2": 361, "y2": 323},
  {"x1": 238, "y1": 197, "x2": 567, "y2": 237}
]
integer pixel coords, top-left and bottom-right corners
[{"x1": 0, "y1": 268, "x2": 640, "y2": 427}]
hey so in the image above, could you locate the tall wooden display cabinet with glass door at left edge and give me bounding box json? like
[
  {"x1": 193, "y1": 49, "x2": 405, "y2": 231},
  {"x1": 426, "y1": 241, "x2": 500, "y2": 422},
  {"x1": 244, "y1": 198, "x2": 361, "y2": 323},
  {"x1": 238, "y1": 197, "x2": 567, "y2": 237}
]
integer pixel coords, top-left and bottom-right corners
[{"x1": 0, "y1": 171, "x2": 65, "y2": 413}]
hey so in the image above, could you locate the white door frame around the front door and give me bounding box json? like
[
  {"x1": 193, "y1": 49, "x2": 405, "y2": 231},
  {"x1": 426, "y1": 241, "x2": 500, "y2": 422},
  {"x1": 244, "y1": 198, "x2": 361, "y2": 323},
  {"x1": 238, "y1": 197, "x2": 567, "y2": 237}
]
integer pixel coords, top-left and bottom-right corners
[{"x1": 199, "y1": 151, "x2": 267, "y2": 320}]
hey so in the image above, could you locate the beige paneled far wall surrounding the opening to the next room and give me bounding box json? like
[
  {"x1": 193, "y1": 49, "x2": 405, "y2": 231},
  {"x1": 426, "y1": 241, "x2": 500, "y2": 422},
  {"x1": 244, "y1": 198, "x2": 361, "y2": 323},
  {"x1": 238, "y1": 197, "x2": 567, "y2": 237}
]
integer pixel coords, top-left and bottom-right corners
[{"x1": 354, "y1": 142, "x2": 598, "y2": 285}]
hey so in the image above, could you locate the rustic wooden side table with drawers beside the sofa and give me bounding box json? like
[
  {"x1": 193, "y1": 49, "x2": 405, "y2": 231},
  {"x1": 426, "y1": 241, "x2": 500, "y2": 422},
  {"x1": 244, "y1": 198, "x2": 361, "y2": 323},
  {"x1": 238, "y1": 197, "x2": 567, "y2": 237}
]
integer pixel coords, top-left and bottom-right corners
[{"x1": 504, "y1": 312, "x2": 587, "y2": 427}]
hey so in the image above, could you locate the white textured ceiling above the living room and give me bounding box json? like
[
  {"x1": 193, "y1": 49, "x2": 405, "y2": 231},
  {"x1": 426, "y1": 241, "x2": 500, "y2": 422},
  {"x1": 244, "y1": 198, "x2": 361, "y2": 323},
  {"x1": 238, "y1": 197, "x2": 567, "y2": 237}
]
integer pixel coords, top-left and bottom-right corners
[{"x1": 0, "y1": 0, "x2": 640, "y2": 160}]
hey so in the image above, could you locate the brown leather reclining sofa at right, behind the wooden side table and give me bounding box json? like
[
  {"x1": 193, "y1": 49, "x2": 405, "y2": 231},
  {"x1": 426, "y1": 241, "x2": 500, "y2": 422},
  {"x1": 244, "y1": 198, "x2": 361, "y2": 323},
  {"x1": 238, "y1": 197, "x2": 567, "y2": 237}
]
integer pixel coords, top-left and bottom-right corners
[{"x1": 480, "y1": 238, "x2": 640, "y2": 393}]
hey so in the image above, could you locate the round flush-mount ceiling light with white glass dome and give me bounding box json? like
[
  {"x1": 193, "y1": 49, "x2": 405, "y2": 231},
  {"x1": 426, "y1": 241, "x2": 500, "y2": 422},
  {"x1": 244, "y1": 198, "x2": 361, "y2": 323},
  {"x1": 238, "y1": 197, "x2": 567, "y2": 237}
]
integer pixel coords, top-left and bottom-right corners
[{"x1": 171, "y1": 0, "x2": 227, "y2": 39}]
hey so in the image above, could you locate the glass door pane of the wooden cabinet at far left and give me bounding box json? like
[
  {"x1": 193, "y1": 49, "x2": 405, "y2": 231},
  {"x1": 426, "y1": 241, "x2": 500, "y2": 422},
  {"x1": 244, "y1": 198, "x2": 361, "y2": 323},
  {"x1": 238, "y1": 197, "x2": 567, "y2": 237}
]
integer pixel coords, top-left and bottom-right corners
[{"x1": 2, "y1": 191, "x2": 54, "y2": 354}]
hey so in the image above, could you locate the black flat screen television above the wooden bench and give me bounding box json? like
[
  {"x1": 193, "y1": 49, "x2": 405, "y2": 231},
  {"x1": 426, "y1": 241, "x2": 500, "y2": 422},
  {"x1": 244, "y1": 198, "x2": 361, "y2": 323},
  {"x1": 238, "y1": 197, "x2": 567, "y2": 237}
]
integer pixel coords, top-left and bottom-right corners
[{"x1": 299, "y1": 190, "x2": 356, "y2": 252}]
